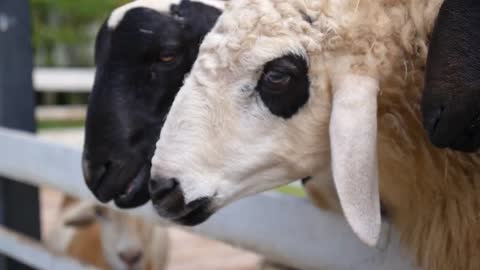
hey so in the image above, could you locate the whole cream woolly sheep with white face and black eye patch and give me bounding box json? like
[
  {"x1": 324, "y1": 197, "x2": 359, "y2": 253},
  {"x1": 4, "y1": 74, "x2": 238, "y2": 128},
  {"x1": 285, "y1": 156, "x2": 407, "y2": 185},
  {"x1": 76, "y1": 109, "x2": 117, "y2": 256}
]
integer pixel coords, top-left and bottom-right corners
[{"x1": 150, "y1": 0, "x2": 480, "y2": 270}]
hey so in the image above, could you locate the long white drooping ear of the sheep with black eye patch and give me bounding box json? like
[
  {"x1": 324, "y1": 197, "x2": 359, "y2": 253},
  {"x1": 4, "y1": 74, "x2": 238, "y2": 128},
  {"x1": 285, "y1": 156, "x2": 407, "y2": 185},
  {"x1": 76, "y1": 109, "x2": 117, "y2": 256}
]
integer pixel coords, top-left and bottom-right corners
[{"x1": 330, "y1": 74, "x2": 381, "y2": 246}]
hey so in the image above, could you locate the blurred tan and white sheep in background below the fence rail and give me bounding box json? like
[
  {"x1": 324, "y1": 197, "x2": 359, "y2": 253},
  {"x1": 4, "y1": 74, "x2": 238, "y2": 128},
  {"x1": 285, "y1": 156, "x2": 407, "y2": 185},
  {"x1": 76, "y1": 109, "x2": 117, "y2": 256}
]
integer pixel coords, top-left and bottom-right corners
[{"x1": 45, "y1": 198, "x2": 169, "y2": 270}]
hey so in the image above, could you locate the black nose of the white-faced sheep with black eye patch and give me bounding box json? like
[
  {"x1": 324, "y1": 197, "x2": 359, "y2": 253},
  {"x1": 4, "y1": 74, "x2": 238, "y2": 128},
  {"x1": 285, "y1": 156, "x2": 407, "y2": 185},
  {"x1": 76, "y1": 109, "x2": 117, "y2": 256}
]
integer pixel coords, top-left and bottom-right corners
[{"x1": 148, "y1": 177, "x2": 186, "y2": 218}]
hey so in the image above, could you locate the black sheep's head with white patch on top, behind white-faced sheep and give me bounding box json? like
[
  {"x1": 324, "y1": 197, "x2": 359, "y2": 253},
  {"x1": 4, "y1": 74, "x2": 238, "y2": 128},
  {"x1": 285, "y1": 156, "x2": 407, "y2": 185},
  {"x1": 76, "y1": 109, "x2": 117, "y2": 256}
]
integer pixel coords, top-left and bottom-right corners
[{"x1": 82, "y1": 0, "x2": 223, "y2": 207}]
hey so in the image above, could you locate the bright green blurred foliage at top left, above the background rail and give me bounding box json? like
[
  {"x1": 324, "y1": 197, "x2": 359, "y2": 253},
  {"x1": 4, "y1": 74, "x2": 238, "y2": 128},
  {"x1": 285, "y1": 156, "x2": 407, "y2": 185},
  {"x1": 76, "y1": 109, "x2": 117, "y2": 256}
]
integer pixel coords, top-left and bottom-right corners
[{"x1": 30, "y1": 0, "x2": 129, "y2": 65}]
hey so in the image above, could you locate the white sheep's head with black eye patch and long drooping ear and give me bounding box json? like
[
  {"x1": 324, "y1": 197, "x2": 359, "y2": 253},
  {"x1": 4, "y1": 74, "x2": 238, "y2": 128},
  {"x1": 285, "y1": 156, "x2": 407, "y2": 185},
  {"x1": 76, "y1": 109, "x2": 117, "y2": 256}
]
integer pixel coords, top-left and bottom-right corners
[{"x1": 150, "y1": 0, "x2": 380, "y2": 245}]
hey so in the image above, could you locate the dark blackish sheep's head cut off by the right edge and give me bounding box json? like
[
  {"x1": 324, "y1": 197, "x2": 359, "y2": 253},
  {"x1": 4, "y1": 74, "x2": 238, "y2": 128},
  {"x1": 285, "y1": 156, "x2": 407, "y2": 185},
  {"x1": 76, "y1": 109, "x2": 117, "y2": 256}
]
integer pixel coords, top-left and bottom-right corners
[{"x1": 422, "y1": 0, "x2": 480, "y2": 151}]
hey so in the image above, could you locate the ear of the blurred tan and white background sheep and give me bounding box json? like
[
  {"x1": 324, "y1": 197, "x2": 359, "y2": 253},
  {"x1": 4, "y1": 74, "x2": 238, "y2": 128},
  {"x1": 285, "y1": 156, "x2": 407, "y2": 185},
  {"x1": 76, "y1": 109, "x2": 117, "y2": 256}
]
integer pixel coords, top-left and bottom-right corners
[{"x1": 63, "y1": 202, "x2": 96, "y2": 227}]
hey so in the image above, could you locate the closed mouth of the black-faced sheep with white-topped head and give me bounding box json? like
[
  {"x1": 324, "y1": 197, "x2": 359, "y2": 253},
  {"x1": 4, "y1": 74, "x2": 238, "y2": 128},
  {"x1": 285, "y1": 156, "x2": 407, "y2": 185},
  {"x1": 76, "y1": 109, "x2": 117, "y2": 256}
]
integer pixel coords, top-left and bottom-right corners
[{"x1": 114, "y1": 165, "x2": 150, "y2": 208}]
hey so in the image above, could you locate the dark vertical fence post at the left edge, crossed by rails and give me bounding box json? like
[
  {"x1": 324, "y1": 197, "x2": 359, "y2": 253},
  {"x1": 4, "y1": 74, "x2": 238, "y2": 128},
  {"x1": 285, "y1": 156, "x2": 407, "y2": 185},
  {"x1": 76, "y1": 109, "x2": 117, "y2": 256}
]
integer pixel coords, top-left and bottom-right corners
[{"x1": 0, "y1": 0, "x2": 40, "y2": 270}]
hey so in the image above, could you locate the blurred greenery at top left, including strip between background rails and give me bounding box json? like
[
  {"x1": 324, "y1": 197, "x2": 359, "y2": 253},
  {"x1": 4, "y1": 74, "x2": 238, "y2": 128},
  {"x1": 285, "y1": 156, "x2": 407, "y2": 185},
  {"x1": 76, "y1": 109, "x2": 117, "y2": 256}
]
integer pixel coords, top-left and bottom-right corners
[{"x1": 30, "y1": 0, "x2": 130, "y2": 105}]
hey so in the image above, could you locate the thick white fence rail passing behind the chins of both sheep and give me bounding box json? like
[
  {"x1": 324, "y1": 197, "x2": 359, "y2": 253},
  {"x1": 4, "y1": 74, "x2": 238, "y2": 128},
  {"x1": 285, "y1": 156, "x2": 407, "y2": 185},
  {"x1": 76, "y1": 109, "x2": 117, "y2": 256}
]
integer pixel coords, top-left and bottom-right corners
[{"x1": 0, "y1": 128, "x2": 413, "y2": 270}]
